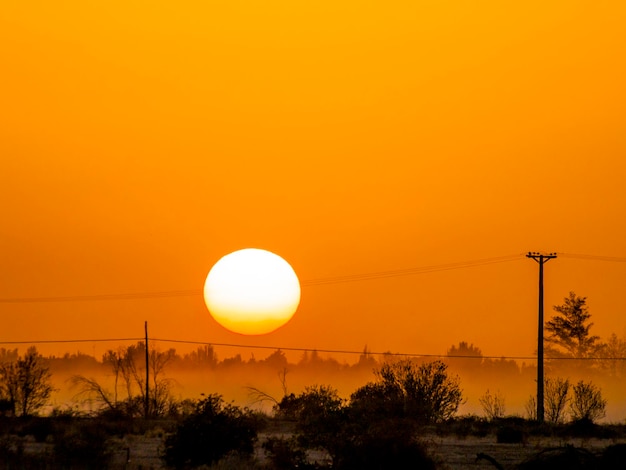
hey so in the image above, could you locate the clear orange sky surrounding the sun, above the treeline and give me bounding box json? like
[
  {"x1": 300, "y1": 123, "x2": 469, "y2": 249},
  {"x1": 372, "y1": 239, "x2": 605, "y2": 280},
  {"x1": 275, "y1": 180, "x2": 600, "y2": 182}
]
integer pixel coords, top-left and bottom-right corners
[{"x1": 0, "y1": 0, "x2": 626, "y2": 357}]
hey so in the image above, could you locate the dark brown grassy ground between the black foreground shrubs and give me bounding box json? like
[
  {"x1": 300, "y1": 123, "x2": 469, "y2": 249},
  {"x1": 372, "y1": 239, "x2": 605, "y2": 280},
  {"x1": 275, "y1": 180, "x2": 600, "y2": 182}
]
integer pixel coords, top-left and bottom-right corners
[{"x1": 0, "y1": 418, "x2": 626, "y2": 470}]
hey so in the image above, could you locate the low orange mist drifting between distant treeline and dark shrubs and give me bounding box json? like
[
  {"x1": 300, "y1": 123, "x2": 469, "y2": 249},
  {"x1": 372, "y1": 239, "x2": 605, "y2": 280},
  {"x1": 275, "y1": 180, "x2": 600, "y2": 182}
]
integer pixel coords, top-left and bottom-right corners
[{"x1": 33, "y1": 343, "x2": 626, "y2": 423}]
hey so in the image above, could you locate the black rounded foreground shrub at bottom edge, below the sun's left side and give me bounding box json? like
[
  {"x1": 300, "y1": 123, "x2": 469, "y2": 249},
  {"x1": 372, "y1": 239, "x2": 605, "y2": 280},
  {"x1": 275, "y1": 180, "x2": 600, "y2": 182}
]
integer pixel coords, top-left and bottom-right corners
[{"x1": 163, "y1": 394, "x2": 259, "y2": 468}]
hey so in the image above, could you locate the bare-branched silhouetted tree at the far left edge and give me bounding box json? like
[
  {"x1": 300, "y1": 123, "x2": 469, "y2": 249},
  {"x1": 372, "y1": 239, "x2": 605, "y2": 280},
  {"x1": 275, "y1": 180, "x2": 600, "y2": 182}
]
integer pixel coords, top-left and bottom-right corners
[{"x1": 0, "y1": 346, "x2": 54, "y2": 416}]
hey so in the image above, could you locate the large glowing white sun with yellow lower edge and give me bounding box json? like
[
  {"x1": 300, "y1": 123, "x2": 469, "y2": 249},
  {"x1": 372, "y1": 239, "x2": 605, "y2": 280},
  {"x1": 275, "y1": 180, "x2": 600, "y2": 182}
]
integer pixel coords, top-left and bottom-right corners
[{"x1": 204, "y1": 248, "x2": 300, "y2": 335}]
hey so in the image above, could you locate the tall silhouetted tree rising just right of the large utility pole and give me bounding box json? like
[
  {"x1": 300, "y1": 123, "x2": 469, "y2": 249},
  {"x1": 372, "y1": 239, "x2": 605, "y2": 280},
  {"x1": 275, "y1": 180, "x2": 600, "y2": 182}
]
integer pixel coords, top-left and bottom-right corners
[{"x1": 545, "y1": 292, "x2": 600, "y2": 358}]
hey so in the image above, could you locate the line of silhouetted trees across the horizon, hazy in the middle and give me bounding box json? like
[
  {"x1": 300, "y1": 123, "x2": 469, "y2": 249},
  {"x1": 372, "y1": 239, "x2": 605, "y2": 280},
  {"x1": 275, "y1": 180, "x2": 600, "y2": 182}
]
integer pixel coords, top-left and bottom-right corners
[{"x1": 0, "y1": 292, "x2": 626, "y2": 416}]
